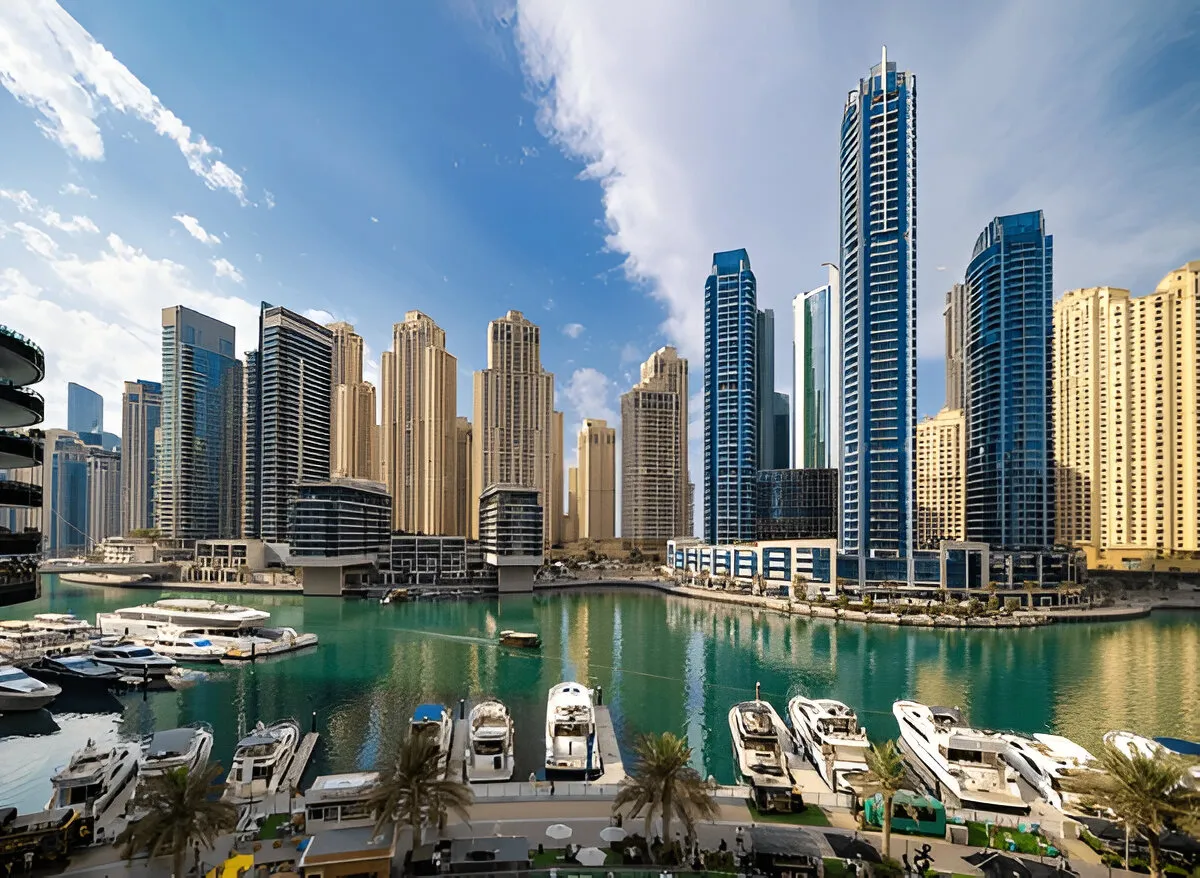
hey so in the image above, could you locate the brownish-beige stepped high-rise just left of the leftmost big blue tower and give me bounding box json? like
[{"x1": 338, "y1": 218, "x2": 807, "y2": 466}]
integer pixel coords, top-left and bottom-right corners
[{"x1": 620, "y1": 347, "x2": 692, "y2": 542}]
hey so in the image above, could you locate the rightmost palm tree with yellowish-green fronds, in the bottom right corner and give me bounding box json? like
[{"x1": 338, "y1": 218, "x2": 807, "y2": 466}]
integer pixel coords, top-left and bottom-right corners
[{"x1": 1062, "y1": 741, "x2": 1200, "y2": 877}]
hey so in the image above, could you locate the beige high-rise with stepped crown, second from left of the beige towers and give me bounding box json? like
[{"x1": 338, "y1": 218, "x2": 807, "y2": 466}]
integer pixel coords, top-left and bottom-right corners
[{"x1": 379, "y1": 311, "x2": 460, "y2": 535}]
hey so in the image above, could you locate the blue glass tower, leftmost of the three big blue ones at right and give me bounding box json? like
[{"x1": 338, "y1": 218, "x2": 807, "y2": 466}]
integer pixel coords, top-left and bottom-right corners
[{"x1": 704, "y1": 249, "x2": 758, "y2": 543}]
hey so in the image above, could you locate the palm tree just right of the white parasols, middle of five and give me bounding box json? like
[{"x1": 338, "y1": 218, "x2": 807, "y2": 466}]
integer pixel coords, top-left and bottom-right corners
[{"x1": 612, "y1": 732, "x2": 719, "y2": 858}]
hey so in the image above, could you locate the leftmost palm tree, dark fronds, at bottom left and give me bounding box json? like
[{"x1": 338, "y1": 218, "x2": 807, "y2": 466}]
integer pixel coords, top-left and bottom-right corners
[{"x1": 116, "y1": 763, "x2": 238, "y2": 878}]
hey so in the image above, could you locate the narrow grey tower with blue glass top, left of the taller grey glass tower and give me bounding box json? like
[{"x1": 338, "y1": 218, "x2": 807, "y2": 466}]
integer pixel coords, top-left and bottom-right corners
[{"x1": 120, "y1": 378, "x2": 162, "y2": 534}]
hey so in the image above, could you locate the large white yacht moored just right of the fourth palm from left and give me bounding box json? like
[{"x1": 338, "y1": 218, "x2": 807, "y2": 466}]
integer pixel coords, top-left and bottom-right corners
[{"x1": 892, "y1": 700, "x2": 1030, "y2": 813}]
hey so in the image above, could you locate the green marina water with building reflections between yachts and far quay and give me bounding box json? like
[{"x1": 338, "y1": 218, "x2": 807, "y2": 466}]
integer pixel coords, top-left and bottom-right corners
[{"x1": 0, "y1": 577, "x2": 1200, "y2": 811}]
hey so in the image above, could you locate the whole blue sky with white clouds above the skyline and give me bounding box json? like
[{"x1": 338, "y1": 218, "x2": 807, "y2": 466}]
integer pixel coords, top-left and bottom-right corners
[{"x1": 0, "y1": 0, "x2": 1200, "y2": 477}]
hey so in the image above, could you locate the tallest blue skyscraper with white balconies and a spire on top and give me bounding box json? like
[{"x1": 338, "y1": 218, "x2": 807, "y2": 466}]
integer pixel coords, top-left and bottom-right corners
[{"x1": 839, "y1": 49, "x2": 917, "y2": 558}]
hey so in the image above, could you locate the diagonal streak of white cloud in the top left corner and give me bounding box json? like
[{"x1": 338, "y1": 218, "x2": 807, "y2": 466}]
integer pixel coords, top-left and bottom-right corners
[{"x1": 0, "y1": 0, "x2": 248, "y2": 205}]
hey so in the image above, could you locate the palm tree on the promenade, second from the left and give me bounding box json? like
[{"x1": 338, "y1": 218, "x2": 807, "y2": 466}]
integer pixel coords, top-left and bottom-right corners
[{"x1": 367, "y1": 732, "x2": 475, "y2": 847}]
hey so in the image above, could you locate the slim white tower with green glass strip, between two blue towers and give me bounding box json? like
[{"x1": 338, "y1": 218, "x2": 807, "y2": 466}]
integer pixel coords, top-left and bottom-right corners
[{"x1": 792, "y1": 263, "x2": 841, "y2": 470}]
